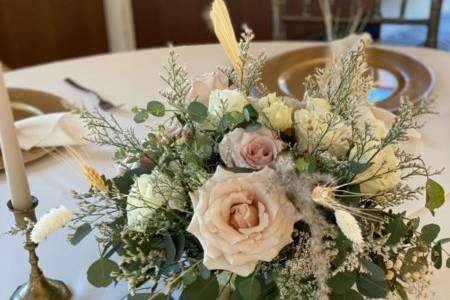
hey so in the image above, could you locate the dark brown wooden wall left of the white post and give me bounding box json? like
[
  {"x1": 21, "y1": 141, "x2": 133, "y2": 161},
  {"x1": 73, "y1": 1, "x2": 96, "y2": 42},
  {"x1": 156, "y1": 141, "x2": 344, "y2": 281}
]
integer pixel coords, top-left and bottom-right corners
[{"x1": 0, "y1": 0, "x2": 108, "y2": 68}]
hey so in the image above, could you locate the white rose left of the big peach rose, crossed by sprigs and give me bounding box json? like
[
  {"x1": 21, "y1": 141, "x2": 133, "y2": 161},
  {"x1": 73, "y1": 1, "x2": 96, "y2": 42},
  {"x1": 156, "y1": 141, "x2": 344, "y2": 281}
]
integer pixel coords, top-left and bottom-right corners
[{"x1": 127, "y1": 170, "x2": 186, "y2": 232}]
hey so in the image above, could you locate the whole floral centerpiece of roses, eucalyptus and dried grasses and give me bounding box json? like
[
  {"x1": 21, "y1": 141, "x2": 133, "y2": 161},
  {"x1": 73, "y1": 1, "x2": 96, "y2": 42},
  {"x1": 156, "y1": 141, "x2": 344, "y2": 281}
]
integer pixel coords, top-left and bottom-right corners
[{"x1": 70, "y1": 0, "x2": 450, "y2": 300}]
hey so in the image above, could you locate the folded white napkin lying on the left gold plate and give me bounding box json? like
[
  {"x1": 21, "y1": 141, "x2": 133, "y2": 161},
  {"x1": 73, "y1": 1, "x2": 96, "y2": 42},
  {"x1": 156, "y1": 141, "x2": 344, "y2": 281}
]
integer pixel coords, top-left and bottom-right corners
[{"x1": 15, "y1": 112, "x2": 87, "y2": 150}]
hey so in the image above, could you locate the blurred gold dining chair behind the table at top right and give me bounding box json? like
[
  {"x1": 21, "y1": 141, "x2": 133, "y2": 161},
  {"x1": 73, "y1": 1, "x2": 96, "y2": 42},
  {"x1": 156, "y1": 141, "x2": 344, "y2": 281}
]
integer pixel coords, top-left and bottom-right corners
[{"x1": 271, "y1": 0, "x2": 442, "y2": 48}]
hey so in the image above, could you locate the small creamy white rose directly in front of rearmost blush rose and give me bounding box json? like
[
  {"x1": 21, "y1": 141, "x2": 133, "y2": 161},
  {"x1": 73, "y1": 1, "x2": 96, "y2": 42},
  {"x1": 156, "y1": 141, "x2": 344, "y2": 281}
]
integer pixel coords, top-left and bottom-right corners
[{"x1": 208, "y1": 89, "x2": 249, "y2": 116}]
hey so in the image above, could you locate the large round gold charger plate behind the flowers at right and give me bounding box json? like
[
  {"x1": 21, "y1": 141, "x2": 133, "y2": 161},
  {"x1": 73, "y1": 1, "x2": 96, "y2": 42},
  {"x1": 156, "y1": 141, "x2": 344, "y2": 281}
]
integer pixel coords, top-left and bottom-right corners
[{"x1": 262, "y1": 46, "x2": 435, "y2": 111}]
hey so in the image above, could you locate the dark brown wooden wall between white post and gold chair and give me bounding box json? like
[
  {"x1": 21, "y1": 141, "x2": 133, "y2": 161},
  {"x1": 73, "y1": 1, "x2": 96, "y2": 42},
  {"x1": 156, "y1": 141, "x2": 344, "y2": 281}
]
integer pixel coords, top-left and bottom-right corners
[{"x1": 133, "y1": 0, "x2": 272, "y2": 48}]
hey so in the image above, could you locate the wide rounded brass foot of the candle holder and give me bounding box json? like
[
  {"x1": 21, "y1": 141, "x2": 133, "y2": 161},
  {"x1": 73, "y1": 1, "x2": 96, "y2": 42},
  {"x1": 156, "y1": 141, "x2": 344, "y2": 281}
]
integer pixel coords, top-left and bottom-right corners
[{"x1": 9, "y1": 277, "x2": 72, "y2": 300}]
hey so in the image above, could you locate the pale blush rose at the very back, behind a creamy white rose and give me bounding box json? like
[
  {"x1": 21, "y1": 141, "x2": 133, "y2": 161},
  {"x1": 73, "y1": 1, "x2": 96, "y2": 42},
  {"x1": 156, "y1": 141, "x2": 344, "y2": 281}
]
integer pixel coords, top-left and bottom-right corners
[{"x1": 187, "y1": 71, "x2": 228, "y2": 106}]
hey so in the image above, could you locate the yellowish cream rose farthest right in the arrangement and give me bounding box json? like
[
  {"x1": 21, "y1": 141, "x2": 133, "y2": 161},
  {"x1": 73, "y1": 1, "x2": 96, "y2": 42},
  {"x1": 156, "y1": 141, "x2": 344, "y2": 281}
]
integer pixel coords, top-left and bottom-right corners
[{"x1": 349, "y1": 145, "x2": 401, "y2": 195}]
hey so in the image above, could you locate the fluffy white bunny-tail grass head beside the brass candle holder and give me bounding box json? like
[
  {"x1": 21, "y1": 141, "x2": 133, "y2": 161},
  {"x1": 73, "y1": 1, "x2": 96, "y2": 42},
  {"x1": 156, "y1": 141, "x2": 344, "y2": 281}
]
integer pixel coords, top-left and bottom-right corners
[{"x1": 31, "y1": 206, "x2": 72, "y2": 243}]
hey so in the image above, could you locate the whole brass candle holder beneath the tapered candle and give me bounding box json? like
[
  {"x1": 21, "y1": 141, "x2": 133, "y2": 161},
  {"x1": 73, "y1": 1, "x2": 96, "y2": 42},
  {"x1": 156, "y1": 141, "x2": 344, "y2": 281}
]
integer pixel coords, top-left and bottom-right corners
[{"x1": 7, "y1": 197, "x2": 72, "y2": 300}]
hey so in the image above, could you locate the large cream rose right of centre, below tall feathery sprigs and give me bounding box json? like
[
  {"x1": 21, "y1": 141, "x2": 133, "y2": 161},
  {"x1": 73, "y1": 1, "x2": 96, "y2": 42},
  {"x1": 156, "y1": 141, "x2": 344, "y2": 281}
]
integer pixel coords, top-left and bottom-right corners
[{"x1": 294, "y1": 98, "x2": 351, "y2": 158}]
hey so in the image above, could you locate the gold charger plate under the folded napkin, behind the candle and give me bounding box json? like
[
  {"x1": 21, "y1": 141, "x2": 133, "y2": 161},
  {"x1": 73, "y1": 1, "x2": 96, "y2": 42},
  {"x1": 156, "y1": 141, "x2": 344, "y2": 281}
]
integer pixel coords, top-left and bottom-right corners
[{"x1": 0, "y1": 88, "x2": 66, "y2": 170}]
